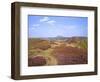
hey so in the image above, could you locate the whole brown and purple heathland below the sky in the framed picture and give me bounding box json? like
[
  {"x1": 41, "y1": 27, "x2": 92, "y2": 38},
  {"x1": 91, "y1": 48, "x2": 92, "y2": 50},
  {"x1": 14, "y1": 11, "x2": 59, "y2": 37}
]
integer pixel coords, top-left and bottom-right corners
[{"x1": 28, "y1": 37, "x2": 88, "y2": 66}]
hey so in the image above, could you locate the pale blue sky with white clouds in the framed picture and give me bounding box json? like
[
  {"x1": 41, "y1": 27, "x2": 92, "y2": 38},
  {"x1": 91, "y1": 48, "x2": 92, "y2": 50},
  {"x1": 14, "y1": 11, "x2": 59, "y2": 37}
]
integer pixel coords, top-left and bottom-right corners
[{"x1": 28, "y1": 15, "x2": 88, "y2": 38}]
